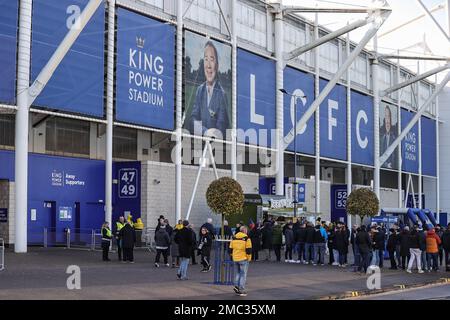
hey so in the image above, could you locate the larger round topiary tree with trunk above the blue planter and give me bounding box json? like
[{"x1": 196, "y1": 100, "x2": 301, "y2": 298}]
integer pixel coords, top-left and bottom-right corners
[{"x1": 206, "y1": 177, "x2": 244, "y2": 235}]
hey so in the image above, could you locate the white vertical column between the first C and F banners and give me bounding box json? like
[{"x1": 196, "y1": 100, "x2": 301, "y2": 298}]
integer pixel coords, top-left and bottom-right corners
[{"x1": 312, "y1": 13, "x2": 320, "y2": 214}]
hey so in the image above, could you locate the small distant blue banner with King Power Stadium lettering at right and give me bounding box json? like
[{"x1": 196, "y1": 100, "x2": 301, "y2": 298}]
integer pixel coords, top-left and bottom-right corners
[{"x1": 401, "y1": 109, "x2": 419, "y2": 173}]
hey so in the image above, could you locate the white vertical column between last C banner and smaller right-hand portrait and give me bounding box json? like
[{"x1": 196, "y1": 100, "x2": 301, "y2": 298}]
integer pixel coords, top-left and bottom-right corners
[{"x1": 372, "y1": 34, "x2": 381, "y2": 202}]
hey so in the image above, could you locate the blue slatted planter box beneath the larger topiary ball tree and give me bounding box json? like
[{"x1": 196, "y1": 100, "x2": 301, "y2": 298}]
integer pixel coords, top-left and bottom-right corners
[{"x1": 214, "y1": 239, "x2": 234, "y2": 285}]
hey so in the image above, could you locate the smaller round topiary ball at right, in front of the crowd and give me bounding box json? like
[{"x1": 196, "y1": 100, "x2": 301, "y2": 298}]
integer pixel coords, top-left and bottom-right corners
[{"x1": 346, "y1": 188, "x2": 380, "y2": 223}]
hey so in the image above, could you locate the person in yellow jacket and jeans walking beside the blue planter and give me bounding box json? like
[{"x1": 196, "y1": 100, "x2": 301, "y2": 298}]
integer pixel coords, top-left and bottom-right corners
[{"x1": 230, "y1": 226, "x2": 252, "y2": 297}]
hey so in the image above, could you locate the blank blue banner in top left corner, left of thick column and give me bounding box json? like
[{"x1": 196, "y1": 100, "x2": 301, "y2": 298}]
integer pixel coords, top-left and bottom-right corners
[{"x1": 0, "y1": 0, "x2": 19, "y2": 104}]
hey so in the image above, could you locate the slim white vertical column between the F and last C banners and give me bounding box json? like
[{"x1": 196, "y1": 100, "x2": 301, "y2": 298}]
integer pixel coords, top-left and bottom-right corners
[{"x1": 345, "y1": 28, "x2": 353, "y2": 230}]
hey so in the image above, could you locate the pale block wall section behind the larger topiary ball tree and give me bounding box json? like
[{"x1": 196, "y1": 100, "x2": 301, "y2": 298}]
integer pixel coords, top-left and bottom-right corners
[{"x1": 141, "y1": 161, "x2": 259, "y2": 228}]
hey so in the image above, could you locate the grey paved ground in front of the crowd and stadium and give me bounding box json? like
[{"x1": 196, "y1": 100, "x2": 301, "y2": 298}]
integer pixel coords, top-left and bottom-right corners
[{"x1": 0, "y1": 248, "x2": 450, "y2": 300}]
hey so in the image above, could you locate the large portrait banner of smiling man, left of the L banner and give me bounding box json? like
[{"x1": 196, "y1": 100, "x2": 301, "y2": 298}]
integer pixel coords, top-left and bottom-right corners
[{"x1": 183, "y1": 31, "x2": 231, "y2": 140}]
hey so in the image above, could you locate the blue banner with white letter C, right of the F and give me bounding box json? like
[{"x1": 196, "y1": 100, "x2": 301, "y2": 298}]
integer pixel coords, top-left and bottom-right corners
[{"x1": 351, "y1": 90, "x2": 374, "y2": 165}]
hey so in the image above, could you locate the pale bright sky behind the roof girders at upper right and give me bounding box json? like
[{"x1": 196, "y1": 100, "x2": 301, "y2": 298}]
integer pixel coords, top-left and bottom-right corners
[{"x1": 283, "y1": 0, "x2": 450, "y2": 81}]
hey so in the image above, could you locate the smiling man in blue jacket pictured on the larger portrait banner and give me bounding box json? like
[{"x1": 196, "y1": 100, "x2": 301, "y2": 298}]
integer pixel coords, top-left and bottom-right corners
[{"x1": 190, "y1": 41, "x2": 229, "y2": 139}]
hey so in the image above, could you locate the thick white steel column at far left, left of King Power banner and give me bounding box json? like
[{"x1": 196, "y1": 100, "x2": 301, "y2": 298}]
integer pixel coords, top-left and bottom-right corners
[{"x1": 14, "y1": 0, "x2": 33, "y2": 253}]
